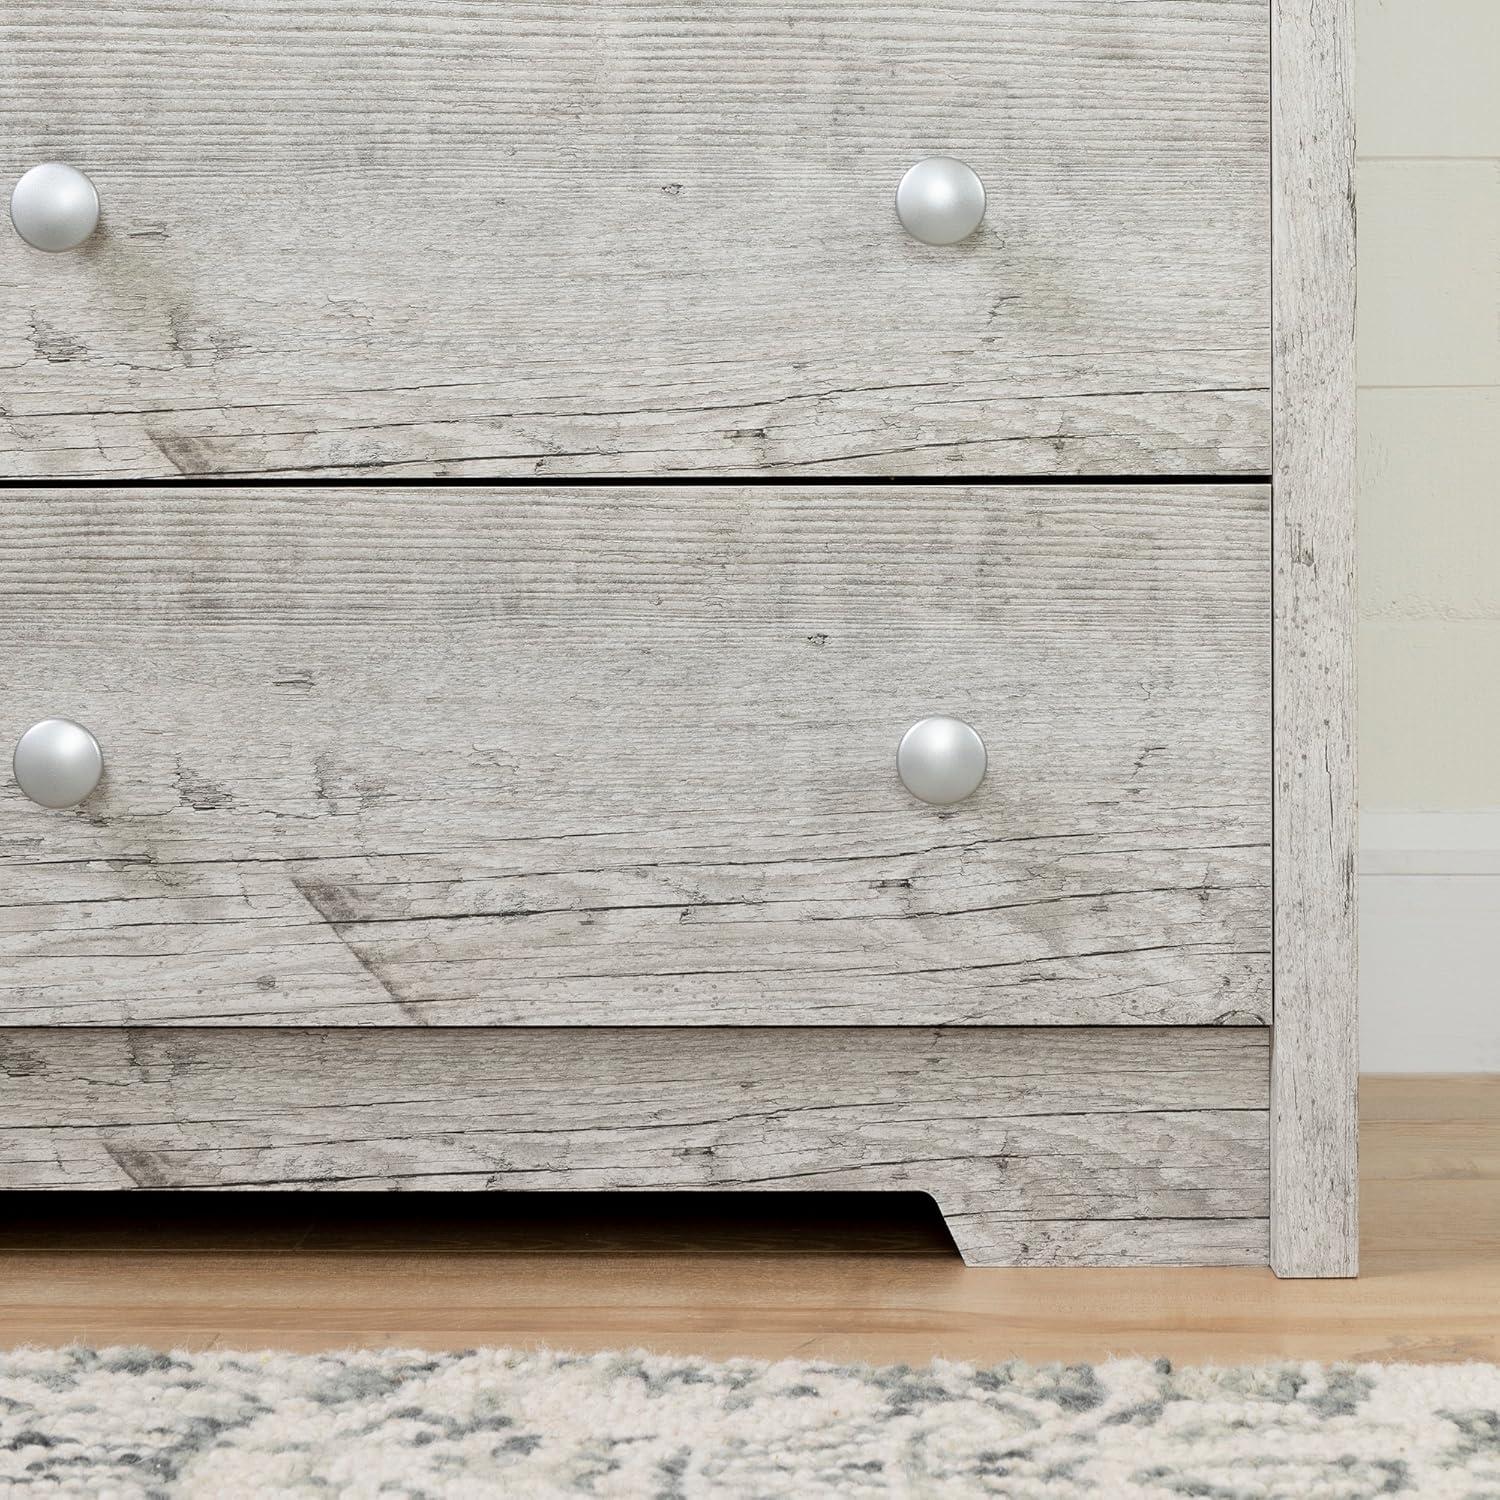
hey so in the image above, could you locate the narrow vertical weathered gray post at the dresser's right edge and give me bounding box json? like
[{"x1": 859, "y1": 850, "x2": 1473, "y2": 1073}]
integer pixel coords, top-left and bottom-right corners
[{"x1": 1272, "y1": 0, "x2": 1359, "y2": 1277}]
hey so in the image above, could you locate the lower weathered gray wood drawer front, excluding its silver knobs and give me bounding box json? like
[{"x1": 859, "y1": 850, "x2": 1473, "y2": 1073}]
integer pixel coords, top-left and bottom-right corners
[{"x1": 0, "y1": 485, "x2": 1271, "y2": 1026}]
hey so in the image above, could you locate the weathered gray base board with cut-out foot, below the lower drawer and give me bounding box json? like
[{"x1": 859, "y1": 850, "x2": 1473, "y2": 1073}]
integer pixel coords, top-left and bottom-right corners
[{"x1": 0, "y1": 1028, "x2": 1269, "y2": 1265}]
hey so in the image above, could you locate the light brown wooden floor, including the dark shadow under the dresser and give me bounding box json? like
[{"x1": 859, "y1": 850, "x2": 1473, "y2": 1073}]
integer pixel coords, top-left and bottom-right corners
[{"x1": 0, "y1": 1077, "x2": 1500, "y2": 1362}]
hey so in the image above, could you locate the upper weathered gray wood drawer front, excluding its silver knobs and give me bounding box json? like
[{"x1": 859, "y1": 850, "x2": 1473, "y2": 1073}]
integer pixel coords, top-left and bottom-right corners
[{"x1": 0, "y1": 0, "x2": 1269, "y2": 479}]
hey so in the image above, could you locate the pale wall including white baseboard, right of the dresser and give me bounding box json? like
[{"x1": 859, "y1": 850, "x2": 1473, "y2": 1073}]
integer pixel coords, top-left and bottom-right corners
[{"x1": 1356, "y1": 0, "x2": 1500, "y2": 1073}]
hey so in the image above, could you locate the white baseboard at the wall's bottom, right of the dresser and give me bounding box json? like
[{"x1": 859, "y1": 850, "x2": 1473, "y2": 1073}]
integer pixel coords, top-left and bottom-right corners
[{"x1": 1359, "y1": 809, "x2": 1500, "y2": 1073}]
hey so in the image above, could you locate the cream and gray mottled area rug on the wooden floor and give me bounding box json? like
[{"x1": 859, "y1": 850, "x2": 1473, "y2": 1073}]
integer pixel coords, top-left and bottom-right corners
[{"x1": 0, "y1": 1349, "x2": 1500, "y2": 1500}]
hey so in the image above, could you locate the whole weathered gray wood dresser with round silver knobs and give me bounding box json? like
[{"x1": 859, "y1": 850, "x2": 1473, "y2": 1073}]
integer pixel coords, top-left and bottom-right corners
[{"x1": 0, "y1": 0, "x2": 1356, "y2": 1275}]
